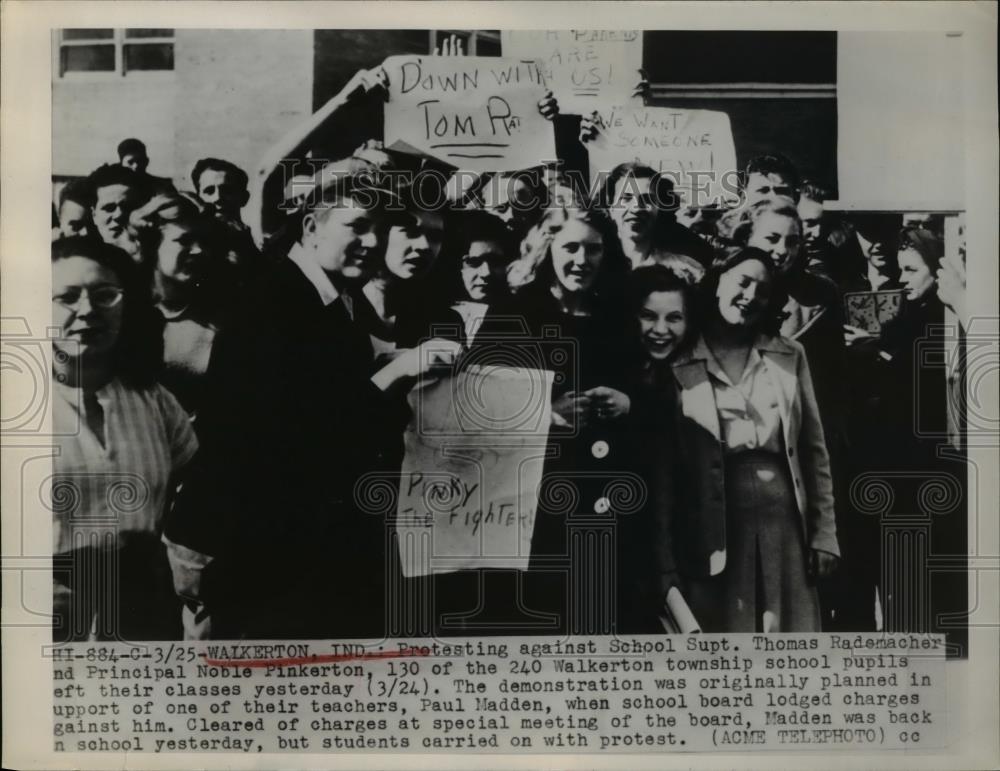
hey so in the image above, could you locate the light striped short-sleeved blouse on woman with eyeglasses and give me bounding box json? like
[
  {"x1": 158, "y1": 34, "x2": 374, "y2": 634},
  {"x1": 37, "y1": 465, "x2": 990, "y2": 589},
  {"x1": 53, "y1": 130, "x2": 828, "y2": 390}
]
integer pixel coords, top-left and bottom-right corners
[{"x1": 52, "y1": 378, "x2": 198, "y2": 554}]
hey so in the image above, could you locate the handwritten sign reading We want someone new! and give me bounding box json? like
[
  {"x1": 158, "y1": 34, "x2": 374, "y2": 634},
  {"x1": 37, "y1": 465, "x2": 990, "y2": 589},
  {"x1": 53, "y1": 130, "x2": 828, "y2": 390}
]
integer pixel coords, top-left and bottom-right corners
[{"x1": 587, "y1": 107, "x2": 736, "y2": 206}]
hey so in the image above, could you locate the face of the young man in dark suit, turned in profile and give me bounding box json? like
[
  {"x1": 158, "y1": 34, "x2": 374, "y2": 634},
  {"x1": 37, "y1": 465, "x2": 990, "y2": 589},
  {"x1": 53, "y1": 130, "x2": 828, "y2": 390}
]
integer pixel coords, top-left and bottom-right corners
[{"x1": 302, "y1": 198, "x2": 379, "y2": 283}]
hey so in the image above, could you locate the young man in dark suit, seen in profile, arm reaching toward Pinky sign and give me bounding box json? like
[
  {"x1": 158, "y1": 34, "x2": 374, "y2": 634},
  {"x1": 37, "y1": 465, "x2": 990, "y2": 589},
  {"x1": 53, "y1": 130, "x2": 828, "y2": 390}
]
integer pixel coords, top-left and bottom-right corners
[{"x1": 164, "y1": 169, "x2": 458, "y2": 639}]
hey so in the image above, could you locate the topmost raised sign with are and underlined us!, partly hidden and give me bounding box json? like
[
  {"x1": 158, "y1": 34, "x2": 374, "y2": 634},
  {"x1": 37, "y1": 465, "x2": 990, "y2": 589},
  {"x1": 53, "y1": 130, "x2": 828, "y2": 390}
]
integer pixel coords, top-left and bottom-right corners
[{"x1": 500, "y1": 29, "x2": 642, "y2": 115}]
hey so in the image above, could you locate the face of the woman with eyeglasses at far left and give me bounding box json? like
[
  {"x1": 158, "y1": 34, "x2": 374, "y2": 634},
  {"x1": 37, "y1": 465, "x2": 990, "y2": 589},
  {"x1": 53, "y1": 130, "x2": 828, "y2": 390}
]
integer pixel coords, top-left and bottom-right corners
[{"x1": 52, "y1": 257, "x2": 124, "y2": 357}]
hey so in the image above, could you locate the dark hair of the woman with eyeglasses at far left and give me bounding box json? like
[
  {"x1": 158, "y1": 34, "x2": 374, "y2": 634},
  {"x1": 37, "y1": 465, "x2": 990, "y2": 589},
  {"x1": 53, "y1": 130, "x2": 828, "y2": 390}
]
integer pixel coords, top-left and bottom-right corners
[{"x1": 52, "y1": 236, "x2": 163, "y2": 388}]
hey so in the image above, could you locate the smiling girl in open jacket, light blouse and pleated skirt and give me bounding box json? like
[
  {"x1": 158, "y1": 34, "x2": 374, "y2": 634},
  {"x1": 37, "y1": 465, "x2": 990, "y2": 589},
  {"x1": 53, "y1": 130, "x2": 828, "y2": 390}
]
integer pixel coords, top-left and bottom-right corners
[{"x1": 671, "y1": 247, "x2": 840, "y2": 632}]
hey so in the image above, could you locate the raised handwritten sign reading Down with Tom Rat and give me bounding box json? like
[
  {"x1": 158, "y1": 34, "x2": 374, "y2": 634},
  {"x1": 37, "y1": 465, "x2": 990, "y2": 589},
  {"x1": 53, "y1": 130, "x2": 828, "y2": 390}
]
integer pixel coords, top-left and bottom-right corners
[{"x1": 384, "y1": 56, "x2": 555, "y2": 172}]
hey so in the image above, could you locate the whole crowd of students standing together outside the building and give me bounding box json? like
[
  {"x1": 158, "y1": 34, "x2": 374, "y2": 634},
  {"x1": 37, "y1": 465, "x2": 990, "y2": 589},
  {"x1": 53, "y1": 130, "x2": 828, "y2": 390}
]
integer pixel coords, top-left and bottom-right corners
[{"x1": 52, "y1": 95, "x2": 965, "y2": 641}]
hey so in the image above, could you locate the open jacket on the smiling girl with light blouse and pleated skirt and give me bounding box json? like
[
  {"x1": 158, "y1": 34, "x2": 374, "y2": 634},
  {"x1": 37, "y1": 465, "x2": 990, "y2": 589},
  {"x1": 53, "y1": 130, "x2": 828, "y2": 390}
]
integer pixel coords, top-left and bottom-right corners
[{"x1": 672, "y1": 335, "x2": 840, "y2": 576}]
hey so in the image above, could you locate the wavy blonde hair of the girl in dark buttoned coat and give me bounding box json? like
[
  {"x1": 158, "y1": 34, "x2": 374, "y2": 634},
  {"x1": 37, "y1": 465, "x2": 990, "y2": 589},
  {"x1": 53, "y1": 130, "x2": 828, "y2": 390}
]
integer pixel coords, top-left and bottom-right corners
[{"x1": 507, "y1": 206, "x2": 630, "y2": 295}]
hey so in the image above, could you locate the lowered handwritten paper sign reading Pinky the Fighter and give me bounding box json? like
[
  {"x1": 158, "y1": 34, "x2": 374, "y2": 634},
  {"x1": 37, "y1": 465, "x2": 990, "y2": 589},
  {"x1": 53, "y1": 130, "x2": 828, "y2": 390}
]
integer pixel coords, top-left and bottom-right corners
[{"x1": 396, "y1": 366, "x2": 552, "y2": 577}]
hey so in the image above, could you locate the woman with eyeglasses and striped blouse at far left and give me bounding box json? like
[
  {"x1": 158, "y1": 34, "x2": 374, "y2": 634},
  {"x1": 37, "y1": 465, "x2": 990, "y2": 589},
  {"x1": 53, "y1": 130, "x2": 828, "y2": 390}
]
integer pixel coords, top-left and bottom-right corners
[{"x1": 51, "y1": 237, "x2": 198, "y2": 641}]
